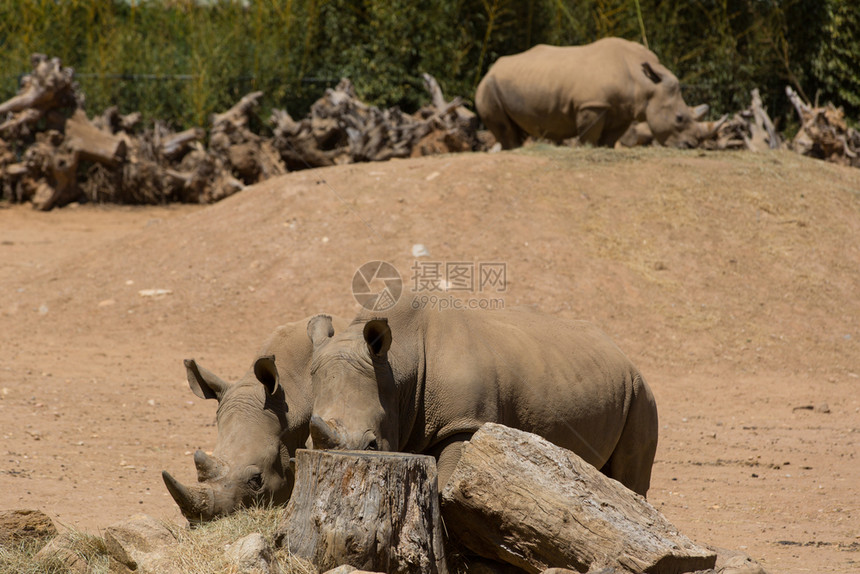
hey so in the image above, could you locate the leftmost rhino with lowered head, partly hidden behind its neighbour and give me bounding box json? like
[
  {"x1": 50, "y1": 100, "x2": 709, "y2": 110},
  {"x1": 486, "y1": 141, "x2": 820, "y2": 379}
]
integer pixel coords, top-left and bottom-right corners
[{"x1": 162, "y1": 318, "x2": 347, "y2": 523}]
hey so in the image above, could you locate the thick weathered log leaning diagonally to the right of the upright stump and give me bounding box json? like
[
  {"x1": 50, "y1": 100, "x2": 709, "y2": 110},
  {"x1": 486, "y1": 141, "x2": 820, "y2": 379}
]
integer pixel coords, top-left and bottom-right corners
[{"x1": 442, "y1": 423, "x2": 715, "y2": 573}]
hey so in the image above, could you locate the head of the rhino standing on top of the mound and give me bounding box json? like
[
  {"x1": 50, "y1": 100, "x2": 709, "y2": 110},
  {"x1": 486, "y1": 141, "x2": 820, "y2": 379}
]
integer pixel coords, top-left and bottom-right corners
[{"x1": 637, "y1": 62, "x2": 719, "y2": 148}]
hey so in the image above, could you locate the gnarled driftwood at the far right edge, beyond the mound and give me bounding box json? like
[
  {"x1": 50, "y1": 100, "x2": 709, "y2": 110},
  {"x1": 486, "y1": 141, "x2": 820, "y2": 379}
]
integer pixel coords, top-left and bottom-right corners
[{"x1": 785, "y1": 86, "x2": 860, "y2": 167}]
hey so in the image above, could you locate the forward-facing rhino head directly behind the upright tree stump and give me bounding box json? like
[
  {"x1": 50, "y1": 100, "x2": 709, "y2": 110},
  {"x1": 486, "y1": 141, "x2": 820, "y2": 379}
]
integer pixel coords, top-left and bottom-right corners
[{"x1": 308, "y1": 315, "x2": 400, "y2": 451}]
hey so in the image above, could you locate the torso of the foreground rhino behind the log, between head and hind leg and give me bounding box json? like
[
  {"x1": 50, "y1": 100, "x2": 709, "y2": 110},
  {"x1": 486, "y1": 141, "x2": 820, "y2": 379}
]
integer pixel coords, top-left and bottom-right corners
[{"x1": 410, "y1": 311, "x2": 638, "y2": 467}]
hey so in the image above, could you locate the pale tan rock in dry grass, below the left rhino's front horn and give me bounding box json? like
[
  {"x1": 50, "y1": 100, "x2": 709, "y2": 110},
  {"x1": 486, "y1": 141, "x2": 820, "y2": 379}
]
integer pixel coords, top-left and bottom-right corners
[{"x1": 104, "y1": 514, "x2": 177, "y2": 574}]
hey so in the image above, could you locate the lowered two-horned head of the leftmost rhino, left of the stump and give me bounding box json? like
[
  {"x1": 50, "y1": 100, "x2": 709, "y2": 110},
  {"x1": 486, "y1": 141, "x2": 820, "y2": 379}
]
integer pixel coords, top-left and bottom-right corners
[{"x1": 162, "y1": 355, "x2": 296, "y2": 524}]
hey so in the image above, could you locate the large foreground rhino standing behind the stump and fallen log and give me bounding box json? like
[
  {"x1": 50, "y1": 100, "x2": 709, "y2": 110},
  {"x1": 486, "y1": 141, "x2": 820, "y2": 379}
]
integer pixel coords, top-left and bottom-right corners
[{"x1": 308, "y1": 303, "x2": 657, "y2": 496}]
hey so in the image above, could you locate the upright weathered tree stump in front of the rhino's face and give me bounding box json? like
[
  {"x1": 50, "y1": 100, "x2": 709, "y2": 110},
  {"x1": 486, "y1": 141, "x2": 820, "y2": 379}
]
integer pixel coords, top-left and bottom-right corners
[{"x1": 276, "y1": 449, "x2": 447, "y2": 573}]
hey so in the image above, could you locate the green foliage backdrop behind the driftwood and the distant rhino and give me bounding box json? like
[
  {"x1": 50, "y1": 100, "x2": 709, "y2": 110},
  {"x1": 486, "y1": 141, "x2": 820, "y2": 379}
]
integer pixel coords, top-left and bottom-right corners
[{"x1": 0, "y1": 0, "x2": 860, "y2": 128}]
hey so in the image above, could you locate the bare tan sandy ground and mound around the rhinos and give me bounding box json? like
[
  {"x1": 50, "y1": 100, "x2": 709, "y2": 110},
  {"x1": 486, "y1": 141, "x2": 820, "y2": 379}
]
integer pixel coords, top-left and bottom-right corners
[{"x1": 0, "y1": 146, "x2": 860, "y2": 572}]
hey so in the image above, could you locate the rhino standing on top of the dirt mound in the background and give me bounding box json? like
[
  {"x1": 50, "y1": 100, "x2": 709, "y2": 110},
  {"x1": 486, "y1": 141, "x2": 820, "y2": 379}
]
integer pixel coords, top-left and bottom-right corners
[{"x1": 475, "y1": 38, "x2": 712, "y2": 149}]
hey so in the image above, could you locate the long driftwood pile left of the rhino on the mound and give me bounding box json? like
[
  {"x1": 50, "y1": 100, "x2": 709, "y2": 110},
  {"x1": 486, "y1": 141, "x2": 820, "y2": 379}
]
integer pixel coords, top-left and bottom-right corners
[{"x1": 0, "y1": 54, "x2": 486, "y2": 210}]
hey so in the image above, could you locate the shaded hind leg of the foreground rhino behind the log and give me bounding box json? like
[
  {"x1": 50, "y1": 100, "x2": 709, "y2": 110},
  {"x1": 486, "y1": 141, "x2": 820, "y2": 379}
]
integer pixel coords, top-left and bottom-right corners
[{"x1": 600, "y1": 374, "x2": 658, "y2": 497}]
